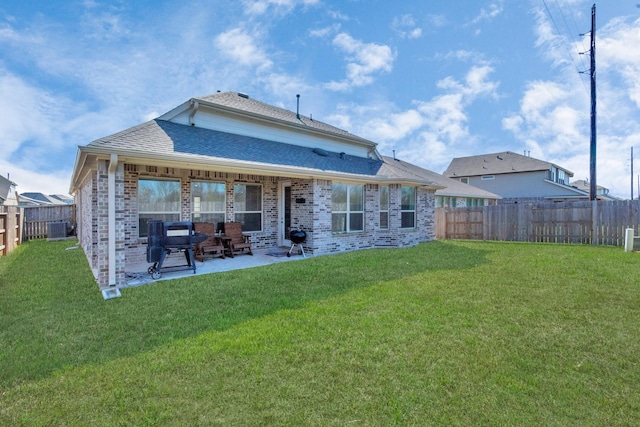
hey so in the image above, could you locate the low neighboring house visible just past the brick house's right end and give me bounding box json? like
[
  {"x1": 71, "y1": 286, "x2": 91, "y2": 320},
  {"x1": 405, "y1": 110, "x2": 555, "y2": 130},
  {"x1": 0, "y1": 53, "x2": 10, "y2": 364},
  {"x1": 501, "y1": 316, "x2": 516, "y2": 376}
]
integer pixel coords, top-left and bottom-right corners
[{"x1": 383, "y1": 157, "x2": 500, "y2": 208}]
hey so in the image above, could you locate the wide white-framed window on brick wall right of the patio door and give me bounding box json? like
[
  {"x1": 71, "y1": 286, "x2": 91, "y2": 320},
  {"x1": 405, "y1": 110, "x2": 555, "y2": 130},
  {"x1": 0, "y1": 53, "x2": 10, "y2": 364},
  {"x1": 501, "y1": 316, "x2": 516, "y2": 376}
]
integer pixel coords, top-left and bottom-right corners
[{"x1": 331, "y1": 184, "x2": 364, "y2": 233}]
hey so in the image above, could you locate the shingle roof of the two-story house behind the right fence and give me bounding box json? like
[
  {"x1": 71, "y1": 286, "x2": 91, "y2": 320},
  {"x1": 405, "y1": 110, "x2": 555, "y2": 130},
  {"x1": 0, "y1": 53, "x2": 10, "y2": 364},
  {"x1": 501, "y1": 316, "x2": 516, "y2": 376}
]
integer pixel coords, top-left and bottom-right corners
[{"x1": 442, "y1": 151, "x2": 573, "y2": 177}]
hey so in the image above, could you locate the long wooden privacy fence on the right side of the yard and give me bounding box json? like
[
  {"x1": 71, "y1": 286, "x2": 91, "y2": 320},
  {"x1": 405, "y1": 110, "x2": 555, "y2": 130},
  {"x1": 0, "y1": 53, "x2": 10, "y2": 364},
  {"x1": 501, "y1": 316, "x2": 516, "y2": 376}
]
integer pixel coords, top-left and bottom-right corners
[{"x1": 436, "y1": 200, "x2": 640, "y2": 246}]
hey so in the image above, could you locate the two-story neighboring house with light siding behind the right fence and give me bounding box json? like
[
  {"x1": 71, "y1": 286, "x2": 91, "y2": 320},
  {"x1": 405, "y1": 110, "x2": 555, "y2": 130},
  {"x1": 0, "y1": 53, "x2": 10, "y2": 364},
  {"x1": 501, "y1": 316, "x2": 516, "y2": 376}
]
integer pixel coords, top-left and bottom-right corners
[{"x1": 443, "y1": 151, "x2": 589, "y2": 203}]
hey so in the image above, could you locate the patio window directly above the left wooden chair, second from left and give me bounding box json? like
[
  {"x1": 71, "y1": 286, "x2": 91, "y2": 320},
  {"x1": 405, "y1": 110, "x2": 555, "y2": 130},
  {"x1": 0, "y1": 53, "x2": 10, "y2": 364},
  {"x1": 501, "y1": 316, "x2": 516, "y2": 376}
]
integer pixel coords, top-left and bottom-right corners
[{"x1": 191, "y1": 181, "x2": 226, "y2": 225}]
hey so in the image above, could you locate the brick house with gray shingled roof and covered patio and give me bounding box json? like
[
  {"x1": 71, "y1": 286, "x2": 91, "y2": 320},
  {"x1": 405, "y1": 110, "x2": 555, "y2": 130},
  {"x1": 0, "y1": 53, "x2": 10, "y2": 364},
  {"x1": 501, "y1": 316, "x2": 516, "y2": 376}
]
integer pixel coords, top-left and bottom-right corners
[{"x1": 70, "y1": 92, "x2": 442, "y2": 288}]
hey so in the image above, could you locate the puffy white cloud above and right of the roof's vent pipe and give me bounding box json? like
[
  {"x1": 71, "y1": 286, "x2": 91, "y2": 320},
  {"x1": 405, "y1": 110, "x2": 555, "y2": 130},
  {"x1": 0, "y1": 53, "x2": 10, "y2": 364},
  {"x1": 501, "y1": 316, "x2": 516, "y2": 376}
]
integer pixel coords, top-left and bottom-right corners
[{"x1": 326, "y1": 33, "x2": 395, "y2": 91}]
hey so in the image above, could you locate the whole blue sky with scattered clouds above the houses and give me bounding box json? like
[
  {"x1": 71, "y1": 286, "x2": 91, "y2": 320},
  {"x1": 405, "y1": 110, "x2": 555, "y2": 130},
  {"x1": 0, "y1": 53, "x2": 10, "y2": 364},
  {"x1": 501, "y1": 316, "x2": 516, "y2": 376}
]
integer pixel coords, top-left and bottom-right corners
[{"x1": 0, "y1": 0, "x2": 640, "y2": 198}]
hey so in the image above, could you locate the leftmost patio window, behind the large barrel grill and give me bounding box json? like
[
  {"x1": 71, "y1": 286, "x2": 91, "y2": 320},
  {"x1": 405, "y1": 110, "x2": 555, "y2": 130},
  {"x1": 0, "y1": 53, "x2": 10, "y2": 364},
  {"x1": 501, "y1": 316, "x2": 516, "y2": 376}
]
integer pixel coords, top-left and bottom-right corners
[{"x1": 138, "y1": 178, "x2": 180, "y2": 237}]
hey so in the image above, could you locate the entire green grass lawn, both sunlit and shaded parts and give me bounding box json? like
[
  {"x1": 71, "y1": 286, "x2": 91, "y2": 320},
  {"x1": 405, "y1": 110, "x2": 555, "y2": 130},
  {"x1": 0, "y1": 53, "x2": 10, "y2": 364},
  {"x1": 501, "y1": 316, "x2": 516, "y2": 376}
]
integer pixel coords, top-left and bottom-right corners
[{"x1": 0, "y1": 241, "x2": 640, "y2": 426}]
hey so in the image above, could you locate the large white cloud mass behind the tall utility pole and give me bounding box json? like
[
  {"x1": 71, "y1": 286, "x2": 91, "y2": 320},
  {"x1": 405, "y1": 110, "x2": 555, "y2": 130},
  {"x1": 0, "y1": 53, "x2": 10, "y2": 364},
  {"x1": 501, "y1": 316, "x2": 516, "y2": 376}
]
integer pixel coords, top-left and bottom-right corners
[{"x1": 502, "y1": 10, "x2": 640, "y2": 197}]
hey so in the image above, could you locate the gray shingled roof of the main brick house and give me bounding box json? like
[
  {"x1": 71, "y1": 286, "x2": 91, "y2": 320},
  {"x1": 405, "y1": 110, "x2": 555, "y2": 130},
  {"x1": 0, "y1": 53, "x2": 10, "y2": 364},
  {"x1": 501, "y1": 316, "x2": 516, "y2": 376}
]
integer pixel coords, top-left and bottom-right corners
[{"x1": 72, "y1": 92, "x2": 443, "y2": 189}]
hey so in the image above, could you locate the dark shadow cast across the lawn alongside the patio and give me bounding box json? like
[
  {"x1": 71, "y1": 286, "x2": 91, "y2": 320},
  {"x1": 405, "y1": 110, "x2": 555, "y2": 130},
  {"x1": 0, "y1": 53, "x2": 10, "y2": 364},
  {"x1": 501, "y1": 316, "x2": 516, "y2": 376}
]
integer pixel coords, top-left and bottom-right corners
[{"x1": 0, "y1": 241, "x2": 487, "y2": 387}]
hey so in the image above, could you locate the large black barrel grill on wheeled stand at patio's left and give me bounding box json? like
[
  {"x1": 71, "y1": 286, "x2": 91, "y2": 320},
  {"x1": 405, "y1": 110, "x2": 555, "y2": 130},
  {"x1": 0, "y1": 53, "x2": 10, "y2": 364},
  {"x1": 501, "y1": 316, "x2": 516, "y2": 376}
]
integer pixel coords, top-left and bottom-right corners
[{"x1": 147, "y1": 219, "x2": 207, "y2": 279}]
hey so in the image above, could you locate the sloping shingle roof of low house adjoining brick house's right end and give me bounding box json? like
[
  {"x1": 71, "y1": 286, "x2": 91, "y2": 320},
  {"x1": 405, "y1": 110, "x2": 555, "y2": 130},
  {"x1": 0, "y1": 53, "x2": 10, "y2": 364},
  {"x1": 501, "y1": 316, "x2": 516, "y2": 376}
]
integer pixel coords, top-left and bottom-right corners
[{"x1": 383, "y1": 156, "x2": 502, "y2": 199}]
